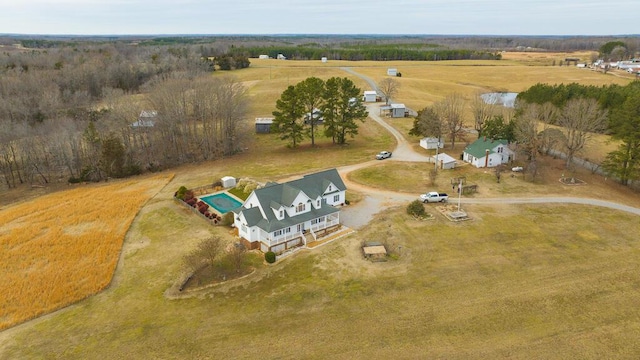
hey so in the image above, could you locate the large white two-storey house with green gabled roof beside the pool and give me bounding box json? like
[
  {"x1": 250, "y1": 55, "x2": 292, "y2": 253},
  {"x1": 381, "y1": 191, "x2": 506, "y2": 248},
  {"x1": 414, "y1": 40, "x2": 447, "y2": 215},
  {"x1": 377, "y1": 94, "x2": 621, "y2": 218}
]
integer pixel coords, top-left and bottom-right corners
[{"x1": 233, "y1": 169, "x2": 347, "y2": 253}]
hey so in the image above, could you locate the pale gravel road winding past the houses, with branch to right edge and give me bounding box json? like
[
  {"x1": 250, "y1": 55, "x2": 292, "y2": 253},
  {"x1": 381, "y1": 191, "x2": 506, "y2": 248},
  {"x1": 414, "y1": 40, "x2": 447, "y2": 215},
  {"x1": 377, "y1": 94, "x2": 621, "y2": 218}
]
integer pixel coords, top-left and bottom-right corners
[{"x1": 338, "y1": 68, "x2": 640, "y2": 229}]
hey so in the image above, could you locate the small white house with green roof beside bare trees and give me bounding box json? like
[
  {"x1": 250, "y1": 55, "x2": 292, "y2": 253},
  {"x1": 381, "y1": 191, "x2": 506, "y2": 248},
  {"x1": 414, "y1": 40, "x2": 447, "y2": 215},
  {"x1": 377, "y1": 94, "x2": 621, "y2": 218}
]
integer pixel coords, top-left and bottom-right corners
[{"x1": 462, "y1": 137, "x2": 515, "y2": 168}]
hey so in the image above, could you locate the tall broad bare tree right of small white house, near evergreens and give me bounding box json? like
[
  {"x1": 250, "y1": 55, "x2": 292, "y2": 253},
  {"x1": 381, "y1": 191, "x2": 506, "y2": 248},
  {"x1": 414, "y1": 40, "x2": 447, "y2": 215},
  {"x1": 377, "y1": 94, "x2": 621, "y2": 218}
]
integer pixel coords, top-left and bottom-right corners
[{"x1": 558, "y1": 99, "x2": 607, "y2": 168}]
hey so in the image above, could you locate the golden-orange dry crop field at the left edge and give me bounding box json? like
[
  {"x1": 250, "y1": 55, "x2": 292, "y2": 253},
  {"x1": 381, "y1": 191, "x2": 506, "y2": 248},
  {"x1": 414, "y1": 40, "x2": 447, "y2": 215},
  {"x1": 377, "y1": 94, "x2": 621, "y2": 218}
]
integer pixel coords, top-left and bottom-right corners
[{"x1": 0, "y1": 175, "x2": 171, "y2": 329}]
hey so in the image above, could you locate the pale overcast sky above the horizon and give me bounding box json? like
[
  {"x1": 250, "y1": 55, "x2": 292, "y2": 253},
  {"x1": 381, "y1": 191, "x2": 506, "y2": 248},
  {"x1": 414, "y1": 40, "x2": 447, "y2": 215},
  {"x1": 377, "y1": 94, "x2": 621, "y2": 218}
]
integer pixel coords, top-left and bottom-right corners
[{"x1": 0, "y1": 0, "x2": 640, "y2": 35}]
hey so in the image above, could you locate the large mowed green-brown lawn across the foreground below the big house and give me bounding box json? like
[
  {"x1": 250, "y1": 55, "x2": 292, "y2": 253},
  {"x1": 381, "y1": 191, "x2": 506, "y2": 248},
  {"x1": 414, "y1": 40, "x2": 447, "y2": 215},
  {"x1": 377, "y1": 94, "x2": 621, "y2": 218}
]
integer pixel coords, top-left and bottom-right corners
[{"x1": 0, "y1": 201, "x2": 640, "y2": 359}]
